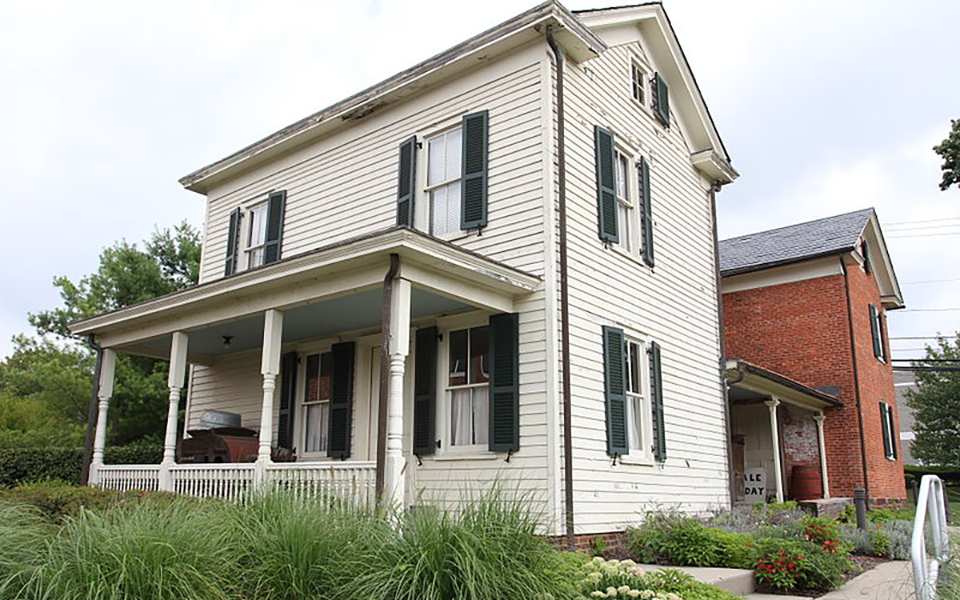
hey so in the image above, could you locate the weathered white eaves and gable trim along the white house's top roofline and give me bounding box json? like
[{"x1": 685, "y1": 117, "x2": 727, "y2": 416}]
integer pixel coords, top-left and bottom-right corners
[{"x1": 180, "y1": 0, "x2": 738, "y2": 193}]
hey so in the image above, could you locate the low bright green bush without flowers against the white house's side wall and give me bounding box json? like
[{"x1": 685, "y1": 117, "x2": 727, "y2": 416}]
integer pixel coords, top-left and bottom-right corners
[{"x1": 630, "y1": 518, "x2": 754, "y2": 569}]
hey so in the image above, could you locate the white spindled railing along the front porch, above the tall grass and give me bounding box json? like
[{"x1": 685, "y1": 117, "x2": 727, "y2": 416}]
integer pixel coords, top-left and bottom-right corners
[{"x1": 96, "y1": 461, "x2": 377, "y2": 506}]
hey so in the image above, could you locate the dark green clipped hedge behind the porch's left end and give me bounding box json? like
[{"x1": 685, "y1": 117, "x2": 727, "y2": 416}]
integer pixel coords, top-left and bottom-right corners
[{"x1": 0, "y1": 443, "x2": 163, "y2": 486}]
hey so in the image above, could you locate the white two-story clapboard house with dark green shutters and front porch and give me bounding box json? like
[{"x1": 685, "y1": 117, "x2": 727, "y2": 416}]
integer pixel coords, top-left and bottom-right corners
[{"x1": 72, "y1": 1, "x2": 736, "y2": 540}]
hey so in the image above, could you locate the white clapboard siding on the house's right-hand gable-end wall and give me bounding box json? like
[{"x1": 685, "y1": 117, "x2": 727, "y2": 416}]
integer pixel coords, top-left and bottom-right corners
[{"x1": 566, "y1": 43, "x2": 729, "y2": 533}]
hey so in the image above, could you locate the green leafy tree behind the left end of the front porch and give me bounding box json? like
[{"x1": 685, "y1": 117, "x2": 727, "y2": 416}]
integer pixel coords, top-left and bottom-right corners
[{"x1": 0, "y1": 223, "x2": 200, "y2": 444}]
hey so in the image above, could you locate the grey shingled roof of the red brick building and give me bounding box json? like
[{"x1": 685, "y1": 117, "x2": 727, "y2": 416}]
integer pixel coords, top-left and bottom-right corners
[{"x1": 720, "y1": 208, "x2": 874, "y2": 277}]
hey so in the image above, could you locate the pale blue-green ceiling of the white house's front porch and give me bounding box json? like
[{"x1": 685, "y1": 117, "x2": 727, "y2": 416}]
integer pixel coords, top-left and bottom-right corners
[{"x1": 137, "y1": 288, "x2": 473, "y2": 362}]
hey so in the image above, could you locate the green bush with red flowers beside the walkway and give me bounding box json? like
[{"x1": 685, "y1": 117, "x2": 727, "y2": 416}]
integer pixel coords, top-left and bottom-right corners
[{"x1": 755, "y1": 539, "x2": 850, "y2": 591}]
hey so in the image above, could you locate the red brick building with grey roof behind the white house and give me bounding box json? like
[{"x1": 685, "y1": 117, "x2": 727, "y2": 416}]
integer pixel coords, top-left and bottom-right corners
[{"x1": 720, "y1": 209, "x2": 905, "y2": 505}]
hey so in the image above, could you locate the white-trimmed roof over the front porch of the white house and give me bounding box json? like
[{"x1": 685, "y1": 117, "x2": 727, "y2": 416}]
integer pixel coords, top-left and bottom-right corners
[{"x1": 70, "y1": 227, "x2": 541, "y2": 364}]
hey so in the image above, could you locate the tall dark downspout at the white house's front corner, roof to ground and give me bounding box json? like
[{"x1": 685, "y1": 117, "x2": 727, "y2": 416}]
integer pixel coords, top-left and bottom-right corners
[{"x1": 546, "y1": 25, "x2": 577, "y2": 550}]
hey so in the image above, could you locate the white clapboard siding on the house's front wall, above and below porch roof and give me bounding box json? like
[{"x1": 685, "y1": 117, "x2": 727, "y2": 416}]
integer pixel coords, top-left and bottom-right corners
[{"x1": 189, "y1": 43, "x2": 556, "y2": 525}]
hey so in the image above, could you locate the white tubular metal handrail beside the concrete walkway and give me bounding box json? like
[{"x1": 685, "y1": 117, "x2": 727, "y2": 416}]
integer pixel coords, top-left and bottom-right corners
[{"x1": 910, "y1": 475, "x2": 950, "y2": 600}]
